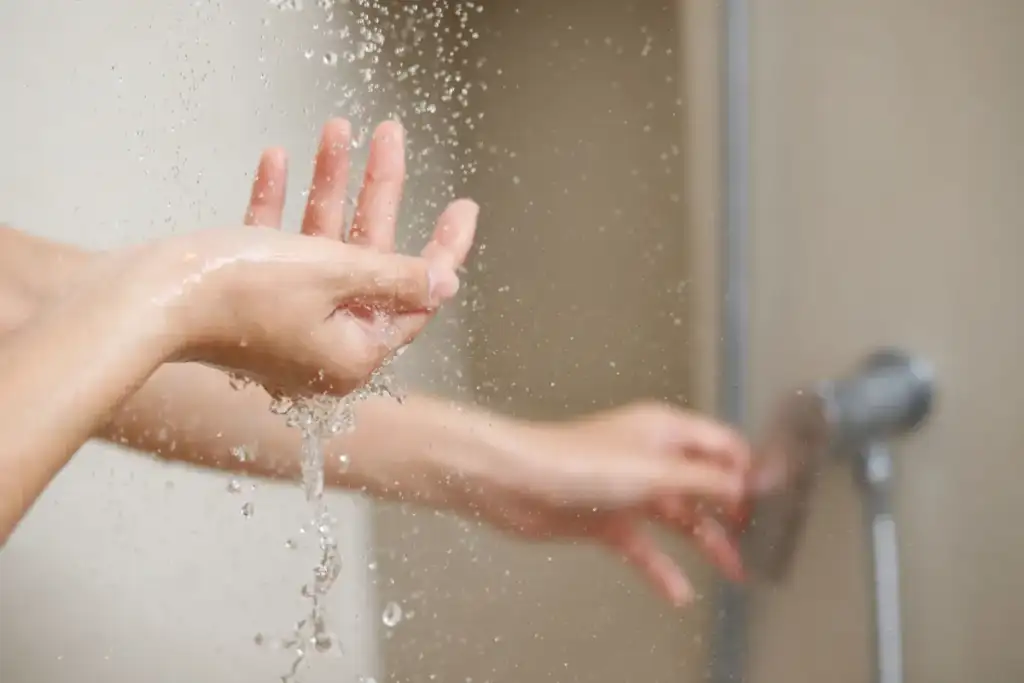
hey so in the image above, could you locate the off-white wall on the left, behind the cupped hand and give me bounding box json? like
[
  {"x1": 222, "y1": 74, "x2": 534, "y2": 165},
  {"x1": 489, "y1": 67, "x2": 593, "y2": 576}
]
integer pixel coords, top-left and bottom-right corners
[{"x1": 0, "y1": 0, "x2": 459, "y2": 683}]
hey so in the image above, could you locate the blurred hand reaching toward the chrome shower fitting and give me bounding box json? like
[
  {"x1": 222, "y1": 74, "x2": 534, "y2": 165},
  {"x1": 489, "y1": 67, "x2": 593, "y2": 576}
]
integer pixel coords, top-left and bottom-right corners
[{"x1": 450, "y1": 403, "x2": 751, "y2": 604}]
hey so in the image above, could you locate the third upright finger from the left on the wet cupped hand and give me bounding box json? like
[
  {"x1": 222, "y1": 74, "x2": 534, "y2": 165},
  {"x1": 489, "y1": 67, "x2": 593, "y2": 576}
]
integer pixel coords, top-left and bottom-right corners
[{"x1": 348, "y1": 121, "x2": 406, "y2": 252}]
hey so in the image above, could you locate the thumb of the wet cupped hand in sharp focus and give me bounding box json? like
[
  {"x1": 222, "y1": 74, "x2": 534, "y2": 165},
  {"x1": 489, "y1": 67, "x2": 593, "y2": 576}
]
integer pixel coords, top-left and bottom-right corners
[{"x1": 334, "y1": 248, "x2": 459, "y2": 312}]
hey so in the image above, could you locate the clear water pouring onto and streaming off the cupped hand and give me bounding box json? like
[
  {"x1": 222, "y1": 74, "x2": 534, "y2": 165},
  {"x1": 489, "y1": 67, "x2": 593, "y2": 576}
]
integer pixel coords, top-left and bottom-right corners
[{"x1": 247, "y1": 0, "x2": 483, "y2": 683}]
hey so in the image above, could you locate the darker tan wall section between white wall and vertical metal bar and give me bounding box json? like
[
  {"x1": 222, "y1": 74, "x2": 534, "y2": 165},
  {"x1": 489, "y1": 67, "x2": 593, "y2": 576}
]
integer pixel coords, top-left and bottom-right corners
[{"x1": 377, "y1": 0, "x2": 708, "y2": 683}]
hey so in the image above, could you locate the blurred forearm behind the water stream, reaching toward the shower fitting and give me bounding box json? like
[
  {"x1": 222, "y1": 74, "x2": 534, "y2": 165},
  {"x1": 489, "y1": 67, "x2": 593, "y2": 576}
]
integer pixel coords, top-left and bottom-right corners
[{"x1": 98, "y1": 364, "x2": 524, "y2": 507}]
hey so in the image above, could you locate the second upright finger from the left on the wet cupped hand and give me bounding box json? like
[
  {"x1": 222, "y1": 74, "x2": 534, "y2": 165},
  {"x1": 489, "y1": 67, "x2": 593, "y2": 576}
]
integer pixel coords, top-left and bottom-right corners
[{"x1": 302, "y1": 119, "x2": 352, "y2": 240}]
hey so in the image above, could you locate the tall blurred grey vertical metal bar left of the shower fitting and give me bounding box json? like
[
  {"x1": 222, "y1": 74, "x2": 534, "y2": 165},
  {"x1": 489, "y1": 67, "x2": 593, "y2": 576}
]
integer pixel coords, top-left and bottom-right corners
[{"x1": 709, "y1": 0, "x2": 750, "y2": 683}]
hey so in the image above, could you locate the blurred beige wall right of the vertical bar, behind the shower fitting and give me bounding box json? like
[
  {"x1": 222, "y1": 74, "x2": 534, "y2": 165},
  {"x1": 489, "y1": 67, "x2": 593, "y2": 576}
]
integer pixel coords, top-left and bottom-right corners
[{"x1": 751, "y1": 0, "x2": 1024, "y2": 683}]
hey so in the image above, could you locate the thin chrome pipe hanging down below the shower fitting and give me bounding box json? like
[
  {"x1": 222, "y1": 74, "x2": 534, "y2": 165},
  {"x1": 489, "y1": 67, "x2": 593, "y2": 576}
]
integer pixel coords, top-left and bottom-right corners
[{"x1": 858, "y1": 441, "x2": 903, "y2": 683}]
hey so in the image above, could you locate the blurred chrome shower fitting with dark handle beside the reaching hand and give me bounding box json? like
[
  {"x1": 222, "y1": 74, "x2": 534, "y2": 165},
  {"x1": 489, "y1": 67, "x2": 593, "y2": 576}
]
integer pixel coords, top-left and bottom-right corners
[{"x1": 742, "y1": 349, "x2": 934, "y2": 582}]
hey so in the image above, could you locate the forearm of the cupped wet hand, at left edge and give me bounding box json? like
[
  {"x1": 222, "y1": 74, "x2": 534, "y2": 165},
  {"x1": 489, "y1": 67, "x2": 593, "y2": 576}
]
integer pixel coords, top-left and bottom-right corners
[{"x1": 0, "y1": 283, "x2": 171, "y2": 544}]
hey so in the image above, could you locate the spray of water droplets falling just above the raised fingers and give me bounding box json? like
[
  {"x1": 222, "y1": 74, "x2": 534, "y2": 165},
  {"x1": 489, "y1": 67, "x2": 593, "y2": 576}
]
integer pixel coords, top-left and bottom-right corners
[{"x1": 269, "y1": 0, "x2": 486, "y2": 228}]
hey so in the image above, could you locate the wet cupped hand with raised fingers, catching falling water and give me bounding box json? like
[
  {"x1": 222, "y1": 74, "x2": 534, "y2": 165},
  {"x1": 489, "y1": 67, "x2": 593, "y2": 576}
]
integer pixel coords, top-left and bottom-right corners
[{"x1": 12, "y1": 120, "x2": 478, "y2": 393}]
